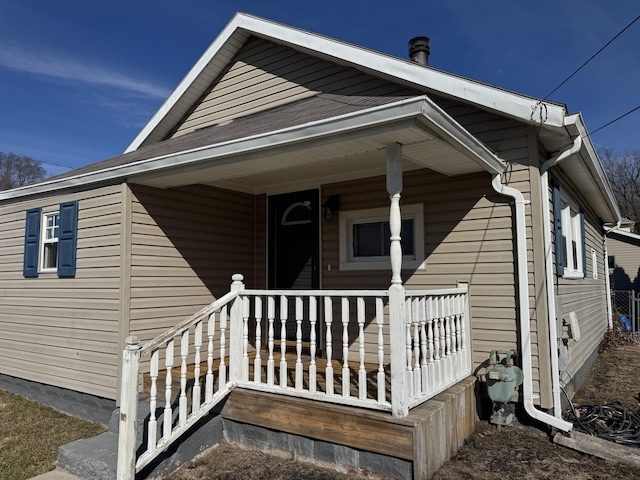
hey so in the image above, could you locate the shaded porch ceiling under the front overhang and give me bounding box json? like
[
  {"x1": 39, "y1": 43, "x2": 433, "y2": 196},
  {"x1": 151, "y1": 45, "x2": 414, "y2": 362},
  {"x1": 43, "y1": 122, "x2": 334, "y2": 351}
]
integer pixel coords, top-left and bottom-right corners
[{"x1": 130, "y1": 121, "x2": 484, "y2": 194}]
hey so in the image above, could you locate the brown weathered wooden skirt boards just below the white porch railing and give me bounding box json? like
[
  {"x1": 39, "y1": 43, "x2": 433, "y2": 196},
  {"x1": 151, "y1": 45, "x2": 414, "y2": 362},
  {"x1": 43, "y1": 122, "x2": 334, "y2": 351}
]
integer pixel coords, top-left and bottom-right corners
[{"x1": 221, "y1": 377, "x2": 477, "y2": 480}]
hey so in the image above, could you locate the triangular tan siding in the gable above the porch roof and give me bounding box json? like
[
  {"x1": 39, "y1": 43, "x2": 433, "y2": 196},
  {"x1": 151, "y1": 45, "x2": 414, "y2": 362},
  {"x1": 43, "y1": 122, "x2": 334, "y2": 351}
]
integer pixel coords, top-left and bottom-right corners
[{"x1": 172, "y1": 38, "x2": 418, "y2": 137}]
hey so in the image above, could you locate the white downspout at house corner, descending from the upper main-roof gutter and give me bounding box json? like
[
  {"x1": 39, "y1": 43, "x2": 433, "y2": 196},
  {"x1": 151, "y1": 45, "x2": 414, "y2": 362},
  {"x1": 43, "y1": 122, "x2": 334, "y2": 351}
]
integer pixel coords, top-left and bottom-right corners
[{"x1": 540, "y1": 136, "x2": 586, "y2": 418}]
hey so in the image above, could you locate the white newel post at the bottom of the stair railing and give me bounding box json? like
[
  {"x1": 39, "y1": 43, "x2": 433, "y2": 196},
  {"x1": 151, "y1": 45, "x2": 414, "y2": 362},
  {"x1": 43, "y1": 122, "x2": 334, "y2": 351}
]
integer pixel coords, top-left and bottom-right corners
[{"x1": 116, "y1": 337, "x2": 140, "y2": 480}]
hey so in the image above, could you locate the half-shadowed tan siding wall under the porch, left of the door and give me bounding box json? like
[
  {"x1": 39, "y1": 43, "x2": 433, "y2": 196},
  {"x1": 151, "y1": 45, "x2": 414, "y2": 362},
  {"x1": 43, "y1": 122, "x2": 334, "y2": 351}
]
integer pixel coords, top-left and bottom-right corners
[{"x1": 130, "y1": 185, "x2": 256, "y2": 340}]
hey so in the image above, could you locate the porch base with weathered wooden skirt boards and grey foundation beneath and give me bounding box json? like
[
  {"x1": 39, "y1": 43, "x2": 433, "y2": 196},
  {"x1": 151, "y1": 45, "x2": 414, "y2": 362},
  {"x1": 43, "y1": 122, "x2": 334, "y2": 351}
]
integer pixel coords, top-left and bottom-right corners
[{"x1": 222, "y1": 377, "x2": 477, "y2": 480}]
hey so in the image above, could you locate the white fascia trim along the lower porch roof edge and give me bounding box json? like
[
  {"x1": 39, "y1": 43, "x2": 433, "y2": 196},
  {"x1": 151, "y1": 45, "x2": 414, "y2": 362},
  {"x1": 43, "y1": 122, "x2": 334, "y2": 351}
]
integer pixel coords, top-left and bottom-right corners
[{"x1": 0, "y1": 96, "x2": 505, "y2": 200}]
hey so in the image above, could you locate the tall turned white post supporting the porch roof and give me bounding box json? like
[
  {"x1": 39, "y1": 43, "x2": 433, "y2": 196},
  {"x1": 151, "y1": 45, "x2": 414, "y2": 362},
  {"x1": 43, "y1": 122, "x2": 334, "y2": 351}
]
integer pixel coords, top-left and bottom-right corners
[{"x1": 387, "y1": 143, "x2": 410, "y2": 417}]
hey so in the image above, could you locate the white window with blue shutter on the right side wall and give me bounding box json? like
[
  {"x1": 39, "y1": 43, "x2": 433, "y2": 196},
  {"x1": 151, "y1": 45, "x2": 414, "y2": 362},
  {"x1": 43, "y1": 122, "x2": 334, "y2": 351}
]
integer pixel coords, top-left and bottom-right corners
[{"x1": 553, "y1": 182, "x2": 587, "y2": 278}]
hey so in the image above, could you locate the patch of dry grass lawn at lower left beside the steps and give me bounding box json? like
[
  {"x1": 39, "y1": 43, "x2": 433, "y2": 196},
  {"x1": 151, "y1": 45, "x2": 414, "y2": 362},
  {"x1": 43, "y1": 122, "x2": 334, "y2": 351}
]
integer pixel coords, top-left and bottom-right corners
[{"x1": 0, "y1": 390, "x2": 105, "y2": 480}]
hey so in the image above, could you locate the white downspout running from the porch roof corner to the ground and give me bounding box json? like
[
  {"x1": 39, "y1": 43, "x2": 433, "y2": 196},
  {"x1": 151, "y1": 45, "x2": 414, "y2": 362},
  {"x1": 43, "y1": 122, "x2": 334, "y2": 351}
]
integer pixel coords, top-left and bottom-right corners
[{"x1": 491, "y1": 175, "x2": 573, "y2": 432}]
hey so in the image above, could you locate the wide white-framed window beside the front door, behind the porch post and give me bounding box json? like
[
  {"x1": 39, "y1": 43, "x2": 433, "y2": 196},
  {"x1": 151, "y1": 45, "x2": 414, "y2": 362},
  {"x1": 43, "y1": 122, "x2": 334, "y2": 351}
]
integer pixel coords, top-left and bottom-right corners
[{"x1": 340, "y1": 205, "x2": 424, "y2": 270}]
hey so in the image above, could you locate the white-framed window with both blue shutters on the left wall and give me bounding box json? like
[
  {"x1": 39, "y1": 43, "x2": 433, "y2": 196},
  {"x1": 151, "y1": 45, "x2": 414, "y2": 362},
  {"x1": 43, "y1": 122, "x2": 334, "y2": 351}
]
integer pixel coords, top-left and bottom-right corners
[{"x1": 23, "y1": 201, "x2": 78, "y2": 278}]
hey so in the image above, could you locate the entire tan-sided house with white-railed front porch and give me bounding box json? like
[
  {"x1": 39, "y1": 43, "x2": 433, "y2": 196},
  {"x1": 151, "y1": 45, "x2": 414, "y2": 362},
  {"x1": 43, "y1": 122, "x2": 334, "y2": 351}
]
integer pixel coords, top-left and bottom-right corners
[{"x1": 0, "y1": 14, "x2": 619, "y2": 478}]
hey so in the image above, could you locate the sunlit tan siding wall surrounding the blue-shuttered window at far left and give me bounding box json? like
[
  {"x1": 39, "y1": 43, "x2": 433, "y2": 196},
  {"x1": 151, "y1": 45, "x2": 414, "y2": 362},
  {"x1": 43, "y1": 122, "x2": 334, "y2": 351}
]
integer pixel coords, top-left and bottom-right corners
[{"x1": 0, "y1": 186, "x2": 121, "y2": 399}]
